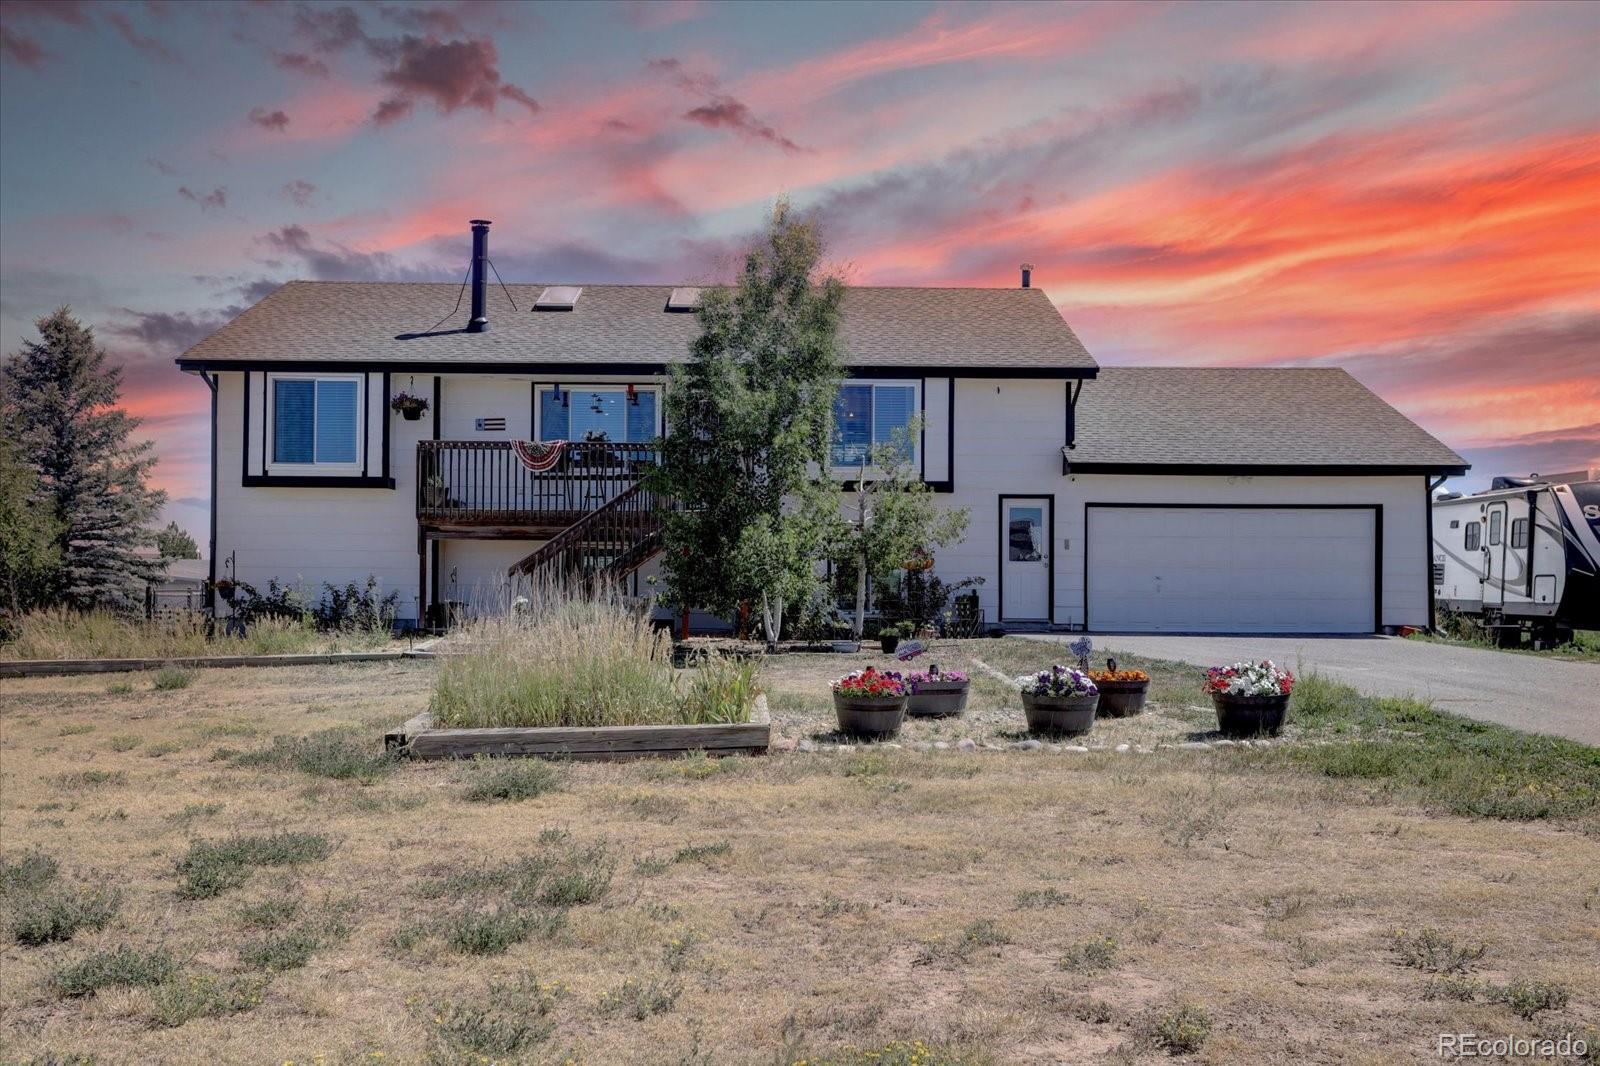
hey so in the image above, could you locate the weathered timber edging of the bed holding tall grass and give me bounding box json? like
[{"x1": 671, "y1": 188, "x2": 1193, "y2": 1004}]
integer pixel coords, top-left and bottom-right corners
[{"x1": 384, "y1": 696, "x2": 773, "y2": 759}]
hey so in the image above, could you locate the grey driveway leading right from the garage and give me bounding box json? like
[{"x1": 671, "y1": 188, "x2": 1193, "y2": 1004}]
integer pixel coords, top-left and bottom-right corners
[{"x1": 1019, "y1": 634, "x2": 1600, "y2": 744}]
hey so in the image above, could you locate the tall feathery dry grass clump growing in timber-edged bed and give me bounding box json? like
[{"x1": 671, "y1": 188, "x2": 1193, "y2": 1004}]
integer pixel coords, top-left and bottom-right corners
[{"x1": 430, "y1": 589, "x2": 757, "y2": 728}]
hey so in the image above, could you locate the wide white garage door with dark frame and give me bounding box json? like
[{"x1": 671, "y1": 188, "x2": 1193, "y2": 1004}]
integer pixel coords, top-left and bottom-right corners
[{"x1": 1086, "y1": 506, "x2": 1378, "y2": 632}]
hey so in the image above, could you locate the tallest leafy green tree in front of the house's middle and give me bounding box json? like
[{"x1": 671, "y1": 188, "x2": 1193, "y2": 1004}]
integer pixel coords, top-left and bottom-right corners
[{"x1": 654, "y1": 196, "x2": 843, "y2": 640}]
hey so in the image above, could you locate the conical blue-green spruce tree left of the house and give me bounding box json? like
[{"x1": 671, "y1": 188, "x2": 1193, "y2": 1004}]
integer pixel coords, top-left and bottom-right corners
[{"x1": 0, "y1": 307, "x2": 166, "y2": 610}]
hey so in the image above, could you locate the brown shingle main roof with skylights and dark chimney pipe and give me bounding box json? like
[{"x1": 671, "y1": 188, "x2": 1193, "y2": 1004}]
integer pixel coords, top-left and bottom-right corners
[{"x1": 179, "y1": 282, "x2": 1094, "y2": 376}]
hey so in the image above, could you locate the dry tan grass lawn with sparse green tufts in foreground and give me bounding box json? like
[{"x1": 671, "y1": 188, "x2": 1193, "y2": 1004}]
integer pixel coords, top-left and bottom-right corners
[{"x1": 0, "y1": 642, "x2": 1600, "y2": 1064}]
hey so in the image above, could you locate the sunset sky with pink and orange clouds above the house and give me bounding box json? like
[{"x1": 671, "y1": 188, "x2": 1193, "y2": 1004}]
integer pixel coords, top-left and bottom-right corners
[{"x1": 0, "y1": 0, "x2": 1600, "y2": 531}]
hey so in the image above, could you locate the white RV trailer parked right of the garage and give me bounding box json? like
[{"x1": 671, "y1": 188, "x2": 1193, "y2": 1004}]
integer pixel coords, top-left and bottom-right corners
[{"x1": 1434, "y1": 477, "x2": 1600, "y2": 643}]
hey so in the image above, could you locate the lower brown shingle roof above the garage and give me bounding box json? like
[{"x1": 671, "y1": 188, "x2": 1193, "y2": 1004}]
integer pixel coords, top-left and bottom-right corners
[{"x1": 1064, "y1": 367, "x2": 1467, "y2": 472}]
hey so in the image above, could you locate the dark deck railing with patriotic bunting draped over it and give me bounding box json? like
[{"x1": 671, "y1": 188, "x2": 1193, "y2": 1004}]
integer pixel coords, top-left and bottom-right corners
[{"x1": 416, "y1": 440, "x2": 658, "y2": 527}]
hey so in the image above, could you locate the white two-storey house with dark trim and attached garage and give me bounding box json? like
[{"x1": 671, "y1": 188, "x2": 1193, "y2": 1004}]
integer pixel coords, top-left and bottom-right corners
[{"x1": 178, "y1": 222, "x2": 1467, "y2": 632}]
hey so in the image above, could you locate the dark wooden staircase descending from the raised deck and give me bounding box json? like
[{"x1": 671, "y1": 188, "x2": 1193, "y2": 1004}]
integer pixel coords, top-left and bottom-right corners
[{"x1": 510, "y1": 483, "x2": 666, "y2": 587}]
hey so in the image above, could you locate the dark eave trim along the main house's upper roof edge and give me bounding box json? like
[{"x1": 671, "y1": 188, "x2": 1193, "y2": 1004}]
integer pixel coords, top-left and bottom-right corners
[{"x1": 178, "y1": 359, "x2": 1099, "y2": 379}]
